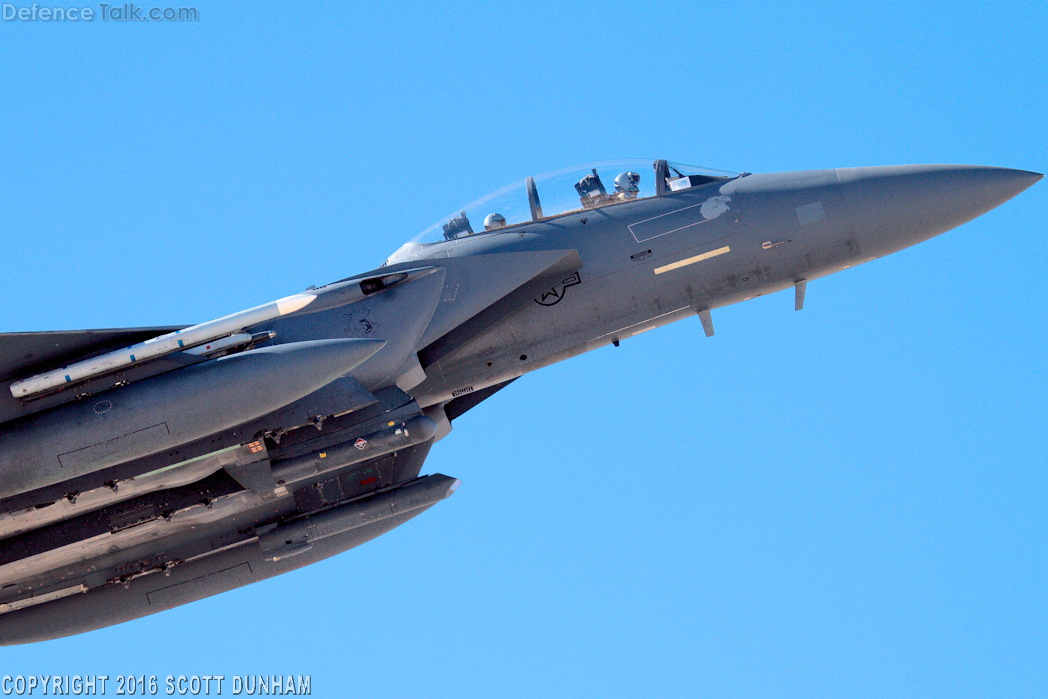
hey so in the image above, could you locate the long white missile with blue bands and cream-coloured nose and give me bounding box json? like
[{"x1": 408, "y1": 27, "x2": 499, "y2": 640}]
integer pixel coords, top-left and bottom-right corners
[{"x1": 10, "y1": 293, "x2": 316, "y2": 399}]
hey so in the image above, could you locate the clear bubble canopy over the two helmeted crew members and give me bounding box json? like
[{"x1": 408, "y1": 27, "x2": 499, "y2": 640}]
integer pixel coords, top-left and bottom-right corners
[{"x1": 384, "y1": 159, "x2": 739, "y2": 264}]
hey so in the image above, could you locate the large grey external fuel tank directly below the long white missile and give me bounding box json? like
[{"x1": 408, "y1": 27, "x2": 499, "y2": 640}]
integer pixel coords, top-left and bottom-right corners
[{"x1": 0, "y1": 338, "x2": 386, "y2": 499}]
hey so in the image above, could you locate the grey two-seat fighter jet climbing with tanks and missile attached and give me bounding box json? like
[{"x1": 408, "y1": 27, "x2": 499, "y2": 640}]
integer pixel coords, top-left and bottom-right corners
[{"x1": 0, "y1": 160, "x2": 1042, "y2": 645}]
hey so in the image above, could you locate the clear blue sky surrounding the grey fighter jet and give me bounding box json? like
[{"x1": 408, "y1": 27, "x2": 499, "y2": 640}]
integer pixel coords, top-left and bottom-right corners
[{"x1": 0, "y1": 0, "x2": 1048, "y2": 697}]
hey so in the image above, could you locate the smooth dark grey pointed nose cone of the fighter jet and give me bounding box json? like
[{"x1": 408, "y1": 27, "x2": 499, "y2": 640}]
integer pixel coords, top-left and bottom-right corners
[{"x1": 837, "y1": 165, "x2": 1044, "y2": 257}]
